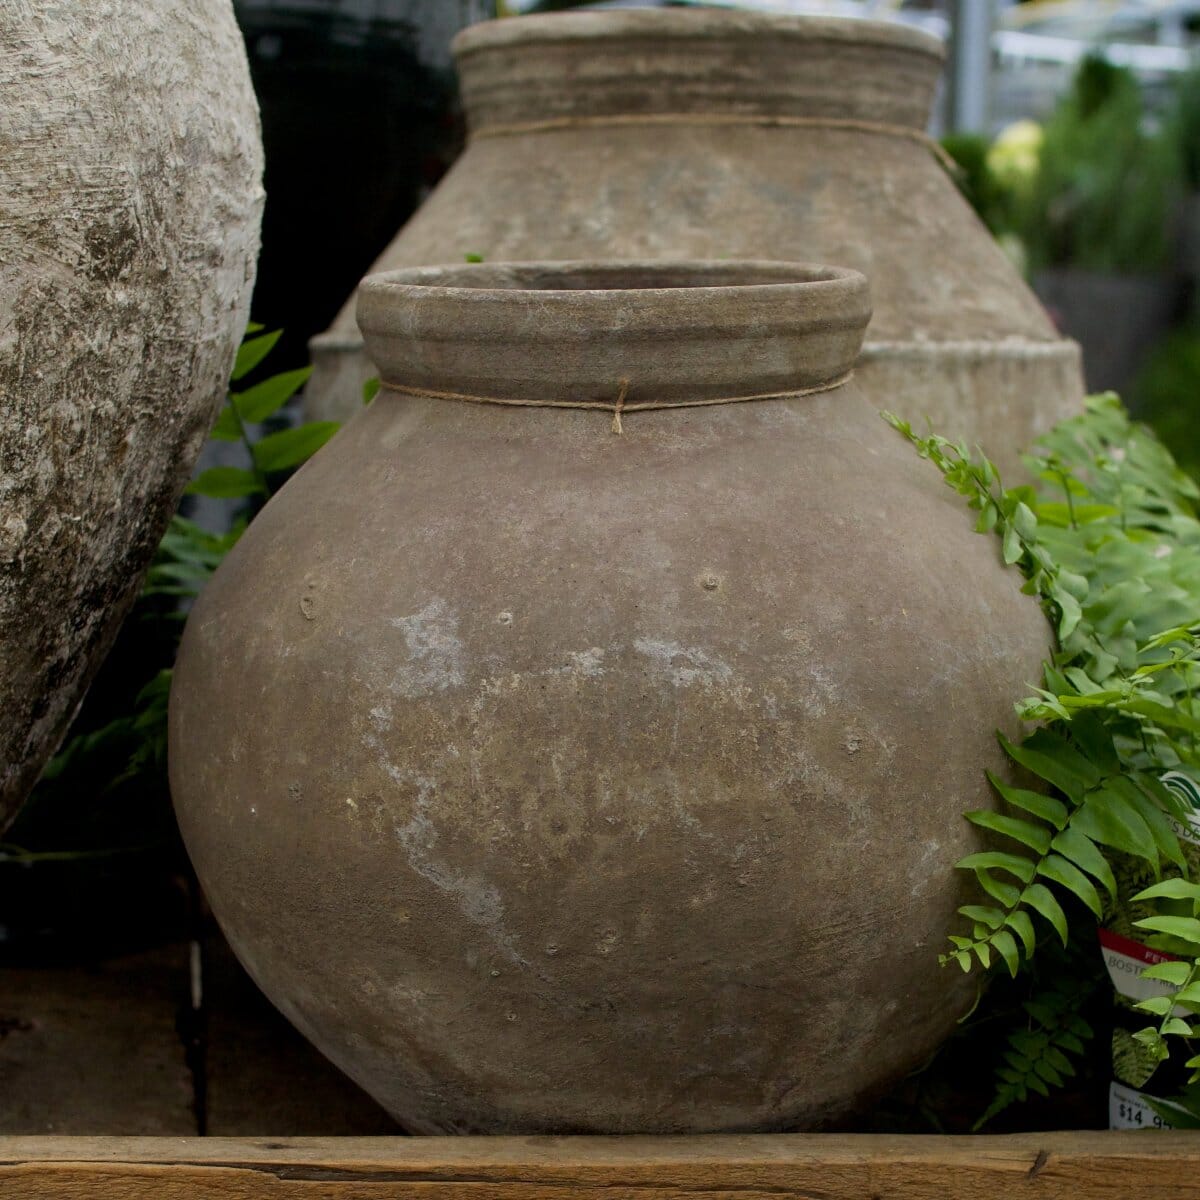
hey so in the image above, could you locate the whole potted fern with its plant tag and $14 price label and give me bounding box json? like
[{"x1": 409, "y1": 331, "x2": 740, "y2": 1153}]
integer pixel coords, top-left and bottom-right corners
[{"x1": 893, "y1": 395, "x2": 1200, "y2": 1128}]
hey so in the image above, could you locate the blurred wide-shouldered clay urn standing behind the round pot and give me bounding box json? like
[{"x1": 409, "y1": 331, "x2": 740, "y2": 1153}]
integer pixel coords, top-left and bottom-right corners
[{"x1": 308, "y1": 10, "x2": 1082, "y2": 466}]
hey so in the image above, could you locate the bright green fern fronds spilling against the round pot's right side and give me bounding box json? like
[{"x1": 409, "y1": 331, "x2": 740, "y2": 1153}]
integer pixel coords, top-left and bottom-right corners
[{"x1": 888, "y1": 396, "x2": 1200, "y2": 1115}]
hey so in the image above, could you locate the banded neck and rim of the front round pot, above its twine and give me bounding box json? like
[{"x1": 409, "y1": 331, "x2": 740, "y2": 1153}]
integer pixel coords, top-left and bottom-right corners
[{"x1": 358, "y1": 263, "x2": 870, "y2": 409}]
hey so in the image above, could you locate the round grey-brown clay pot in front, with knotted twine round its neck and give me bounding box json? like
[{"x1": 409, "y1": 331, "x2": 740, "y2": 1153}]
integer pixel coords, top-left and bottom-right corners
[{"x1": 170, "y1": 264, "x2": 1049, "y2": 1132}]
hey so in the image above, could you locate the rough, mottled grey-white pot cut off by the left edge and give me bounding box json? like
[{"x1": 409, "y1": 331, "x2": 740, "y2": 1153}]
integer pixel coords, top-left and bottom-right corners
[{"x1": 0, "y1": 0, "x2": 263, "y2": 828}]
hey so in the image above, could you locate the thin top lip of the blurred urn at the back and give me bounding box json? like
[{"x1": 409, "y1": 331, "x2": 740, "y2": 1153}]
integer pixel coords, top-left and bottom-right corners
[{"x1": 450, "y1": 8, "x2": 946, "y2": 62}]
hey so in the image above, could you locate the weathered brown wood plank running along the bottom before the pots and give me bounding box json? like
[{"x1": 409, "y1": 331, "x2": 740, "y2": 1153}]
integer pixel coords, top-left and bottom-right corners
[{"x1": 0, "y1": 1133, "x2": 1200, "y2": 1200}]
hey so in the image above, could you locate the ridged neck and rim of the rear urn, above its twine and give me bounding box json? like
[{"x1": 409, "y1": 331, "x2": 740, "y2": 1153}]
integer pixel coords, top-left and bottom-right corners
[{"x1": 454, "y1": 10, "x2": 942, "y2": 132}]
